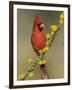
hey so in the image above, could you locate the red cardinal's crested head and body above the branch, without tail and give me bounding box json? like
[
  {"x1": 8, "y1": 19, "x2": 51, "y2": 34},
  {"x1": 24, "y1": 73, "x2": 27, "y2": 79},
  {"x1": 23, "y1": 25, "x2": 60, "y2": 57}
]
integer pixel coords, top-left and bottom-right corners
[{"x1": 31, "y1": 16, "x2": 46, "y2": 54}]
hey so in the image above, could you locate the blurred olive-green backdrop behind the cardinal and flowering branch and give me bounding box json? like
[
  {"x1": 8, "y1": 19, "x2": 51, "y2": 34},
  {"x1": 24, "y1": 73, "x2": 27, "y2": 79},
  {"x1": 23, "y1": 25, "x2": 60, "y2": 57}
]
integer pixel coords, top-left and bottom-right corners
[{"x1": 17, "y1": 9, "x2": 64, "y2": 80}]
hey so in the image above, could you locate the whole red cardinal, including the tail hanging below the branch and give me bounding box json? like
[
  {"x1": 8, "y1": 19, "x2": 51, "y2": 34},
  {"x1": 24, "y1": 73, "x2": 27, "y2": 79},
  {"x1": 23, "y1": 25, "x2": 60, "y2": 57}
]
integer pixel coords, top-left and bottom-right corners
[{"x1": 31, "y1": 16, "x2": 48, "y2": 79}]
